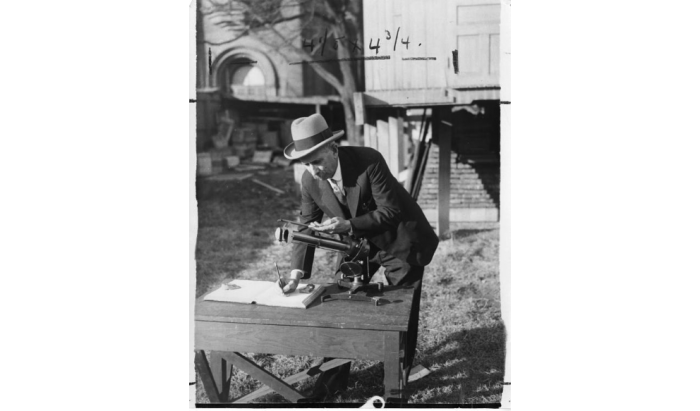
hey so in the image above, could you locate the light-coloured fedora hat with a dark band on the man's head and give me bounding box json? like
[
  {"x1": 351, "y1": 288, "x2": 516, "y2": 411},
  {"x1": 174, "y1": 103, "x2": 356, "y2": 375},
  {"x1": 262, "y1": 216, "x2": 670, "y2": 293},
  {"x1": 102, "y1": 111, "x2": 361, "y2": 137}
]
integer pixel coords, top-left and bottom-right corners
[{"x1": 284, "y1": 114, "x2": 345, "y2": 160}]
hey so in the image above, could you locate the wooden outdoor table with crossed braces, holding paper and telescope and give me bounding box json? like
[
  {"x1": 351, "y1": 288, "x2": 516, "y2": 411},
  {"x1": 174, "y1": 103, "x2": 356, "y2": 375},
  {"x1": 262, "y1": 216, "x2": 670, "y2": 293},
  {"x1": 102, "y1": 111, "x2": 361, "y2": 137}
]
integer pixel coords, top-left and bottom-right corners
[{"x1": 195, "y1": 286, "x2": 413, "y2": 403}]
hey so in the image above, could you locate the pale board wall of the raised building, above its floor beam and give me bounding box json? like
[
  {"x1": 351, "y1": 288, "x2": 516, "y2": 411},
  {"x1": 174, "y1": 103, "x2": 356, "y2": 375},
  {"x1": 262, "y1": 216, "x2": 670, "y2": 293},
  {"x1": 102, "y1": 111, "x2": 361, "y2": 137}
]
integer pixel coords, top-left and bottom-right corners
[{"x1": 363, "y1": 0, "x2": 501, "y2": 91}]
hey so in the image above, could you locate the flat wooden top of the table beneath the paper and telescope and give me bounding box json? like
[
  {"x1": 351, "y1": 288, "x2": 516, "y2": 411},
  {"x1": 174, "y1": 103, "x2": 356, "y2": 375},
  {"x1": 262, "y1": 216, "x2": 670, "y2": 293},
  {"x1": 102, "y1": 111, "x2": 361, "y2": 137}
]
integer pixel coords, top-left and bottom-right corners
[{"x1": 195, "y1": 284, "x2": 413, "y2": 331}]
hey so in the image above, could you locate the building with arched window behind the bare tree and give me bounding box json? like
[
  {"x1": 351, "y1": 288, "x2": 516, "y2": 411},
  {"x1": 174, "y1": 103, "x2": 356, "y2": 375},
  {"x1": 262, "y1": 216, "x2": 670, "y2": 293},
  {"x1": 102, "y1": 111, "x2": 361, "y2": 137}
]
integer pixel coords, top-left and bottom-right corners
[{"x1": 197, "y1": 0, "x2": 363, "y2": 151}]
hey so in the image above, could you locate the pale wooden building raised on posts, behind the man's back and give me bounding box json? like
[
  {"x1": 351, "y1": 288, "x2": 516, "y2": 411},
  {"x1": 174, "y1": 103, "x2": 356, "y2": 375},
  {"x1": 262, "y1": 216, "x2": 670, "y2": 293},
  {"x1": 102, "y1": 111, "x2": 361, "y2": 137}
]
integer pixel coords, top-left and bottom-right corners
[{"x1": 355, "y1": 0, "x2": 501, "y2": 234}]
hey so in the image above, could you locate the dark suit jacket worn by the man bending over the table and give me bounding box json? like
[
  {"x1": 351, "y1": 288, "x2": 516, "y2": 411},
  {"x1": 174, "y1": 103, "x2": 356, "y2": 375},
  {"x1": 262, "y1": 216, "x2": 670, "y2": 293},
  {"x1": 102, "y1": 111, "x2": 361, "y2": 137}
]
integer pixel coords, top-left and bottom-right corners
[{"x1": 292, "y1": 147, "x2": 439, "y2": 279}]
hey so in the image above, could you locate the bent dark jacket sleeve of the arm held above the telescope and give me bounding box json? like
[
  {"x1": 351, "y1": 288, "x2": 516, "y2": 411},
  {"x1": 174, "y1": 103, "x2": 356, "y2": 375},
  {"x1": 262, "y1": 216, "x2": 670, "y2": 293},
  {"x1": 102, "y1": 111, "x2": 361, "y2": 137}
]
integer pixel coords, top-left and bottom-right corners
[{"x1": 350, "y1": 155, "x2": 401, "y2": 236}]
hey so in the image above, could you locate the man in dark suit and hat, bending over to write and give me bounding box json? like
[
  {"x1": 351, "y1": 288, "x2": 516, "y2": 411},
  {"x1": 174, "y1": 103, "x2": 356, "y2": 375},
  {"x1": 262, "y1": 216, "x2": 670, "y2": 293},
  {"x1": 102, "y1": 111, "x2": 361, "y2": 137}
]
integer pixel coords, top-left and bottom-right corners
[{"x1": 285, "y1": 114, "x2": 439, "y2": 395}]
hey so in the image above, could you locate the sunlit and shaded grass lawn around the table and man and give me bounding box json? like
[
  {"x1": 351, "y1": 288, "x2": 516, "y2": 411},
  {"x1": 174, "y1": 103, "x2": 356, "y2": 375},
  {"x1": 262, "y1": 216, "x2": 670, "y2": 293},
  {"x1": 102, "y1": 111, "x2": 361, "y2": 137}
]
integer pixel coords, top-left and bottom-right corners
[{"x1": 196, "y1": 168, "x2": 505, "y2": 407}]
